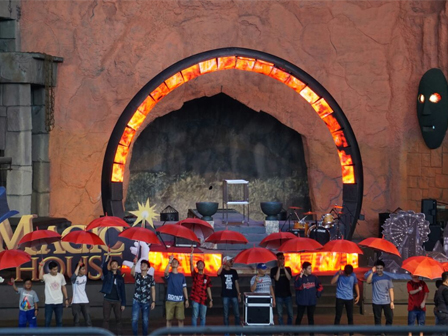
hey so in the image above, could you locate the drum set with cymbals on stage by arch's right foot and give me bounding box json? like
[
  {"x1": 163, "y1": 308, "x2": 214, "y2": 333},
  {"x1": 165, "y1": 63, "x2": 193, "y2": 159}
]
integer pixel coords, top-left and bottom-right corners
[{"x1": 289, "y1": 204, "x2": 343, "y2": 243}]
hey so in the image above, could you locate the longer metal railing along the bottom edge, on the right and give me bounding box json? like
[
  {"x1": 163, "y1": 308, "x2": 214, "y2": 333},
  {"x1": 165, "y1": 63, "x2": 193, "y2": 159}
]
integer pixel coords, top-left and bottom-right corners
[{"x1": 150, "y1": 325, "x2": 448, "y2": 336}]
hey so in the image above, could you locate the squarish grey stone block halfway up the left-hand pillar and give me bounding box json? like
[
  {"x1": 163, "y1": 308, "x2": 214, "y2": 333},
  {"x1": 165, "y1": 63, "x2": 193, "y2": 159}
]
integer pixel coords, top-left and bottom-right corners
[{"x1": 5, "y1": 131, "x2": 32, "y2": 166}]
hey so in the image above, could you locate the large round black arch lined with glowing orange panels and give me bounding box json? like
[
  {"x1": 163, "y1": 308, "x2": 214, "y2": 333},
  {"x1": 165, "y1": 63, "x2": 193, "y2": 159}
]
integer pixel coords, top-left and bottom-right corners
[{"x1": 101, "y1": 48, "x2": 363, "y2": 239}]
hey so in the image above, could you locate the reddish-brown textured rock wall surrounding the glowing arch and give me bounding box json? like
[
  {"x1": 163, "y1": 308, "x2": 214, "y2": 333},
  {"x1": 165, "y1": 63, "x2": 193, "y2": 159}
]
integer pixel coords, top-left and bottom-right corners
[{"x1": 15, "y1": 0, "x2": 448, "y2": 236}]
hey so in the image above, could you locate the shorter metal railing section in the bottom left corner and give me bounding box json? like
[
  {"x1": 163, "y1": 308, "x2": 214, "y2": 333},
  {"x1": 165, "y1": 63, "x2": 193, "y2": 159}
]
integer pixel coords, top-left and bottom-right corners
[{"x1": 0, "y1": 327, "x2": 115, "y2": 336}]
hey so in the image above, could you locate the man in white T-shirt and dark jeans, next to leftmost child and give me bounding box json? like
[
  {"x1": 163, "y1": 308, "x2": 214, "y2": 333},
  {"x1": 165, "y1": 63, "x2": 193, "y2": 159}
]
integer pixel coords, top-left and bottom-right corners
[{"x1": 39, "y1": 261, "x2": 68, "y2": 327}]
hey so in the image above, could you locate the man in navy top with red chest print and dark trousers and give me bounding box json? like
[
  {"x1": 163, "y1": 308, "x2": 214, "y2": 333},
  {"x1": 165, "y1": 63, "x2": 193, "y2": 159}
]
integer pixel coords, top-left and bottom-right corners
[{"x1": 294, "y1": 261, "x2": 324, "y2": 325}]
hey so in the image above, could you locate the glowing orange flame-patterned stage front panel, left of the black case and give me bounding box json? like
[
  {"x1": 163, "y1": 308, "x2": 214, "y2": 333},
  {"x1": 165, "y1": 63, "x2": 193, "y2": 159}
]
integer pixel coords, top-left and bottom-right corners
[{"x1": 148, "y1": 251, "x2": 222, "y2": 276}]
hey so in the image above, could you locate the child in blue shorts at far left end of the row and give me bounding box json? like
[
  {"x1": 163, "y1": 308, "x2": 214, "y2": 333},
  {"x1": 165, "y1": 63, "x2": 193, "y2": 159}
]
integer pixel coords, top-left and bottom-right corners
[{"x1": 11, "y1": 278, "x2": 39, "y2": 328}]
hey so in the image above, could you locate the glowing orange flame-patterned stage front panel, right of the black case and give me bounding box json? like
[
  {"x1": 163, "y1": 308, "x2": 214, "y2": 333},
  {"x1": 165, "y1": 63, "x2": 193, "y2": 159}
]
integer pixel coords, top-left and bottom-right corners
[{"x1": 284, "y1": 252, "x2": 359, "y2": 274}]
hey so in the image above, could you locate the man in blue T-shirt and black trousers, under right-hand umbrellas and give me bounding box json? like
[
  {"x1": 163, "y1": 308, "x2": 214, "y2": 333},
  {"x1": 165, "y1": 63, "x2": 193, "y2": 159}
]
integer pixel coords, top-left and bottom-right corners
[{"x1": 331, "y1": 265, "x2": 359, "y2": 334}]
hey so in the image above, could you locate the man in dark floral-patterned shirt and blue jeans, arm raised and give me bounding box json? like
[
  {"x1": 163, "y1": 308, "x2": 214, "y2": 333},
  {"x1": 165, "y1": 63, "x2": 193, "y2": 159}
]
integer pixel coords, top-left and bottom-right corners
[{"x1": 131, "y1": 260, "x2": 156, "y2": 336}]
